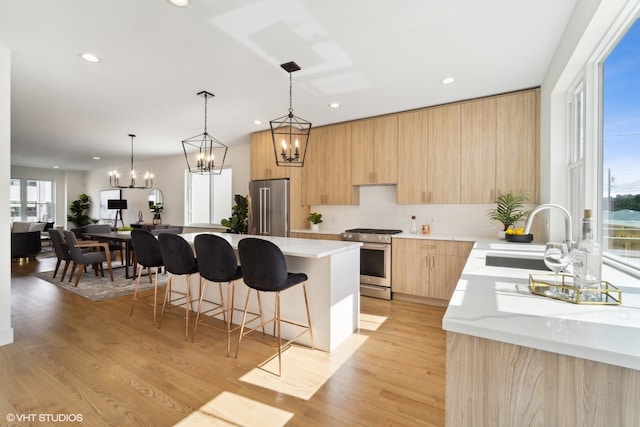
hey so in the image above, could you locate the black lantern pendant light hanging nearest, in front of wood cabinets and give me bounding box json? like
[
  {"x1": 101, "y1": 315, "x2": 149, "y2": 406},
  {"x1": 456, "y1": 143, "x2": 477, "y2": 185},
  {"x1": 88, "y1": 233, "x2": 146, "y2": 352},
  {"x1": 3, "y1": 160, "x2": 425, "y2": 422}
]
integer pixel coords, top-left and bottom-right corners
[{"x1": 269, "y1": 61, "x2": 311, "y2": 167}]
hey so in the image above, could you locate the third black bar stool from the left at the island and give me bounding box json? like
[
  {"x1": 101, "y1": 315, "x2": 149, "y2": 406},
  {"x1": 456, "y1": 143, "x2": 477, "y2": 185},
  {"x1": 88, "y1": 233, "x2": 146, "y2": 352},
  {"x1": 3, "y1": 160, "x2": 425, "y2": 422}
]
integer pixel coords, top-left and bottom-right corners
[{"x1": 191, "y1": 234, "x2": 242, "y2": 356}]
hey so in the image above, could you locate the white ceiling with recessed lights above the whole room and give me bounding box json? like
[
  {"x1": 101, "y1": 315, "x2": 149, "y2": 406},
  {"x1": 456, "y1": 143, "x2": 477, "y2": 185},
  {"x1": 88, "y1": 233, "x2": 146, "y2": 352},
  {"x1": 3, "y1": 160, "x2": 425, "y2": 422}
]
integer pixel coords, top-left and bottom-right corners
[{"x1": 0, "y1": 0, "x2": 576, "y2": 170}]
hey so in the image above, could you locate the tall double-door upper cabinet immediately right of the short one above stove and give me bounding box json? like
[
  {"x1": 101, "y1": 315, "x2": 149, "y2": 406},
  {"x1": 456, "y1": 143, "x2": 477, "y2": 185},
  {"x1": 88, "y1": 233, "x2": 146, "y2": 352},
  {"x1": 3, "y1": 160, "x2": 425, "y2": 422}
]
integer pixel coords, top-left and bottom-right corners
[{"x1": 397, "y1": 104, "x2": 460, "y2": 204}]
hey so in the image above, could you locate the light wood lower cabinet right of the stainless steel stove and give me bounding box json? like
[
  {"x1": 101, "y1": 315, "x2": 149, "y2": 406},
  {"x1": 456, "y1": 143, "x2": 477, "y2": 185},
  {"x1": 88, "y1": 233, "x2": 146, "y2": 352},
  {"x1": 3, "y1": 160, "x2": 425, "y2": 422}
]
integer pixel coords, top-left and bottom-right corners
[{"x1": 391, "y1": 238, "x2": 473, "y2": 303}]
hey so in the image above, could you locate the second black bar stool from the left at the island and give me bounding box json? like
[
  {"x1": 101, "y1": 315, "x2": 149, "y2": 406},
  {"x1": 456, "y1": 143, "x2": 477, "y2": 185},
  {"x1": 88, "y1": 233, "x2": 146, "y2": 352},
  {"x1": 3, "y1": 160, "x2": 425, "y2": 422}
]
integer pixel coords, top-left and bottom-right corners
[{"x1": 158, "y1": 233, "x2": 198, "y2": 341}]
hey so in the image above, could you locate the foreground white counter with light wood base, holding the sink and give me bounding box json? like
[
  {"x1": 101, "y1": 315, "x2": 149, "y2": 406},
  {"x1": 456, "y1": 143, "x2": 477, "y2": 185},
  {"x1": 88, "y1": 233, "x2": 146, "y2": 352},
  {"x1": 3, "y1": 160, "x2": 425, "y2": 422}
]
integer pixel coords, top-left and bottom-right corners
[{"x1": 443, "y1": 243, "x2": 640, "y2": 426}]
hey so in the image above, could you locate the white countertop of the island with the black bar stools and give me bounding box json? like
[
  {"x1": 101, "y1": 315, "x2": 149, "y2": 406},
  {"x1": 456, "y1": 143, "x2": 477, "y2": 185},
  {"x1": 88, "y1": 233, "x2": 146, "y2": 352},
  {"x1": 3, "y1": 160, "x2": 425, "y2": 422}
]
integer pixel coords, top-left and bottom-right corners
[{"x1": 181, "y1": 232, "x2": 362, "y2": 258}]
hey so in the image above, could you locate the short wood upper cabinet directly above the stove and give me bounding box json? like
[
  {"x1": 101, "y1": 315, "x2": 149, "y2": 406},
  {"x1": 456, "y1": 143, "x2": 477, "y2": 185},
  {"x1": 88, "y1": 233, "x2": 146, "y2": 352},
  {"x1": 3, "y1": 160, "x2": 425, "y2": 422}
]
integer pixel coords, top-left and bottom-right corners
[{"x1": 351, "y1": 114, "x2": 398, "y2": 185}]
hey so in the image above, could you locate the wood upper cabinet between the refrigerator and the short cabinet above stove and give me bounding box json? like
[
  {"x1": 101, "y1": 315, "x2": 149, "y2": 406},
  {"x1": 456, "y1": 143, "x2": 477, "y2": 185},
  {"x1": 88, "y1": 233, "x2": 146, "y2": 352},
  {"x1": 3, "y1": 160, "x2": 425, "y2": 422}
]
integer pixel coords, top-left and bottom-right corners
[{"x1": 302, "y1": 123, "x2": 358, "y2": 205}]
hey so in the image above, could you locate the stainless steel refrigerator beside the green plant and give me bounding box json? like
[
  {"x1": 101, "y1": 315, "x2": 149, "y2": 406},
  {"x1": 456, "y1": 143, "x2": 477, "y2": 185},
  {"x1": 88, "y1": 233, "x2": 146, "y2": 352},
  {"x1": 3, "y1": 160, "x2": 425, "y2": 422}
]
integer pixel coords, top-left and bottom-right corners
[{"x1": 249, "y1": 179, "x2": 289, "y2": 237}]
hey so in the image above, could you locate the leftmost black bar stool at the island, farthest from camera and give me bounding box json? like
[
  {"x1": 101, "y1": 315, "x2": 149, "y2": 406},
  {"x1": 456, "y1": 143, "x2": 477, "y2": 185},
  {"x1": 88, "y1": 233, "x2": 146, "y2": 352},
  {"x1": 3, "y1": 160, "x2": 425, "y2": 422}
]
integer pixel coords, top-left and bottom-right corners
[{"x1": 129, "y1": 228, "x2": 164, "y2": 326}]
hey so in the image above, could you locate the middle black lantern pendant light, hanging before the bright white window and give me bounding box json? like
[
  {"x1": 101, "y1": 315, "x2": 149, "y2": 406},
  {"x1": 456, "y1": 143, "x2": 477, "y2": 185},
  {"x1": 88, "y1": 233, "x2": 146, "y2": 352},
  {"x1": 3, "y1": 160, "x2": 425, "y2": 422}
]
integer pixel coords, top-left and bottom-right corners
[{"x1": 182, "y1": 90, "x2": 227, "y2": 175}]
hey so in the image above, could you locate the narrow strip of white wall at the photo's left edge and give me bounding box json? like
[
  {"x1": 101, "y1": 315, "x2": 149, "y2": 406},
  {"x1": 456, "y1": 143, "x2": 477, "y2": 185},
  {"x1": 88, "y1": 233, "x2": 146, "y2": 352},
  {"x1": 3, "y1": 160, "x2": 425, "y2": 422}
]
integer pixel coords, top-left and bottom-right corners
[{"x1": 0, "y1": 46, "x2": 13, "y2": 345}]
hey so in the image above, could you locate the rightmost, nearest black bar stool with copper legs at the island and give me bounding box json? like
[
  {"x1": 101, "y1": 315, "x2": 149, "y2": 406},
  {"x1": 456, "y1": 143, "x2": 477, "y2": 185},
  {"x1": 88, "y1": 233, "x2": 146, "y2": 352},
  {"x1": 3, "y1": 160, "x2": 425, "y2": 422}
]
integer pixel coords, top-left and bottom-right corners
[{"x1": 236, "y1": 237, "x2": 315, "y2": 376}]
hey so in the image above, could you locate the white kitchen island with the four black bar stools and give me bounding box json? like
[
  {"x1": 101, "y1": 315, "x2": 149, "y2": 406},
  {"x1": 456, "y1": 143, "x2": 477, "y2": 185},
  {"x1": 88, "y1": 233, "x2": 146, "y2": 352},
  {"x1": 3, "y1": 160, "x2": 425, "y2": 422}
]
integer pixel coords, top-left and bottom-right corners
[{"x1": 181, "y1": 233, "x2": 362, "y2": 352}]
